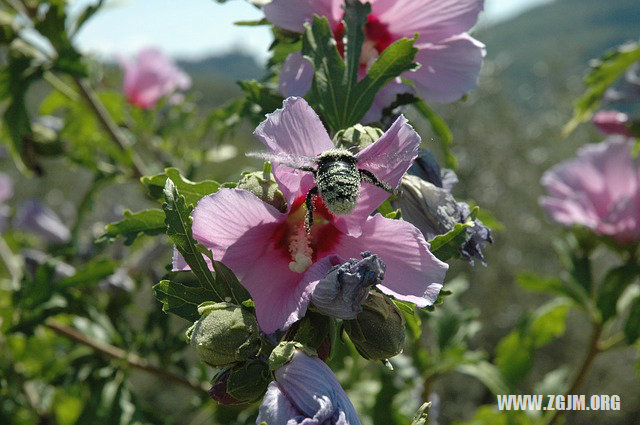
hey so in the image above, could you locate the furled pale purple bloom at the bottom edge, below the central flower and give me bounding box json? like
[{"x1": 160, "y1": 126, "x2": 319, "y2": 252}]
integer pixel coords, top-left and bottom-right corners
[{"x1": 256, "y1": 351, "x2": 360, "y2": 425}]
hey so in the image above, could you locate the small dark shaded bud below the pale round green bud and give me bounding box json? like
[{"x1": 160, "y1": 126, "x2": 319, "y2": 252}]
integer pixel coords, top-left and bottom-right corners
[{"x1": 209, "y1": 360, "x2": 272, "y2": 404}]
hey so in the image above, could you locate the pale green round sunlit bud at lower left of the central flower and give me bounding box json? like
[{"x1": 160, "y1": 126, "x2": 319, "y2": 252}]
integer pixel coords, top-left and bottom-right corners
[{"x1": 187, "y1": 303, "x2": 260, "y2": 367}]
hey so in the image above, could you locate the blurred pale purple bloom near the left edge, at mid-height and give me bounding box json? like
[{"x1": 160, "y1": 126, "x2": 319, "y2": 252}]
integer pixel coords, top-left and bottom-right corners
[{"x1": 13, "y1": 199, "x2": 71, "y2": 244}]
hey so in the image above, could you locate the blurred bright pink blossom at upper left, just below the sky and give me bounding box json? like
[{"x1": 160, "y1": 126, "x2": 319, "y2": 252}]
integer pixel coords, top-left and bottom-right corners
[{"x1": 120, "y1": 48, "x2": 191, "y2": 109}]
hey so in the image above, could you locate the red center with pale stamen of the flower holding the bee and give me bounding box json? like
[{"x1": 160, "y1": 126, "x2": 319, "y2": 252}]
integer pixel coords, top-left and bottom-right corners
[{"x1": 273, "y1": 196, "x2": 341, "y2": 273}]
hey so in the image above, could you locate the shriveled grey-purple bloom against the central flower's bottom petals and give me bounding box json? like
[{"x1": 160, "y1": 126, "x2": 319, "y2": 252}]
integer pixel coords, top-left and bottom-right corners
[{"x1": 311, "y1": 252, "x2": 386, "y2": 320}]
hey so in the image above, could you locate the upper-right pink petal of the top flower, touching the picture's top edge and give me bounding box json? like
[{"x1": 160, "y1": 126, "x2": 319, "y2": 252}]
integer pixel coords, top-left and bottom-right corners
[{"x1": 372, "y1": 0, "x2": 484, "y2": 43}]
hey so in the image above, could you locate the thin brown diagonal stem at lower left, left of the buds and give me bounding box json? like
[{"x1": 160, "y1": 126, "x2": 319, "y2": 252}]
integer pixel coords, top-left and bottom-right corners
[{"x1": 45, "y1": 320, "x2": 208, "y2": 393}]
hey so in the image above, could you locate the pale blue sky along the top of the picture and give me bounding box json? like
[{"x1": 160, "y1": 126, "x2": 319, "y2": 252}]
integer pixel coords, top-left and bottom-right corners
[{"x1": 73, "y1": 0, "x2": 550, "y2": 59}]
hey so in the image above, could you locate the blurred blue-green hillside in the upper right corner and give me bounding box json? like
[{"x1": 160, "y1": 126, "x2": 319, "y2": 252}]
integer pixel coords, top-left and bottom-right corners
[{"x1": 475, "y1": 0, "x2": 640, "y2": 106}]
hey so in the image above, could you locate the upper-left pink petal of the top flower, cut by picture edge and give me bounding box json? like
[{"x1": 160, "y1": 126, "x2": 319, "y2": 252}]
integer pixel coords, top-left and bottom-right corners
[{"x1": 262, "y1": 0, "x2": 343, "y2": 32}]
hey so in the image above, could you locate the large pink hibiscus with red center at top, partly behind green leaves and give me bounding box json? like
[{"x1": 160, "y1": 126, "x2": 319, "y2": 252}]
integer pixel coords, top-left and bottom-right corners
[{"x1": 263, "y1": 0, "x2": 485, "y2": 121}]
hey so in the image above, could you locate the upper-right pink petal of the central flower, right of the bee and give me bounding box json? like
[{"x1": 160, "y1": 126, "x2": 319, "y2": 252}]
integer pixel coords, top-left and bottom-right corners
[{"x1": 335, "y1": 116, "x2": 420, "y2": 236}]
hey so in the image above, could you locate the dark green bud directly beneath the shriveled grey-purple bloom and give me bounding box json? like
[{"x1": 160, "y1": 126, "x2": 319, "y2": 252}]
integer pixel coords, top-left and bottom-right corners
[{"x1": 344, "y1": 292, "x2": 405, "y2": 360}]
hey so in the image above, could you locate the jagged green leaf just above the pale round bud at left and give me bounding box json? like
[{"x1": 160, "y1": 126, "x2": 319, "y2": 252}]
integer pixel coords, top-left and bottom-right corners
[{"x1": 153, "y1": 280, "x2": 217, "y2": 322}]
